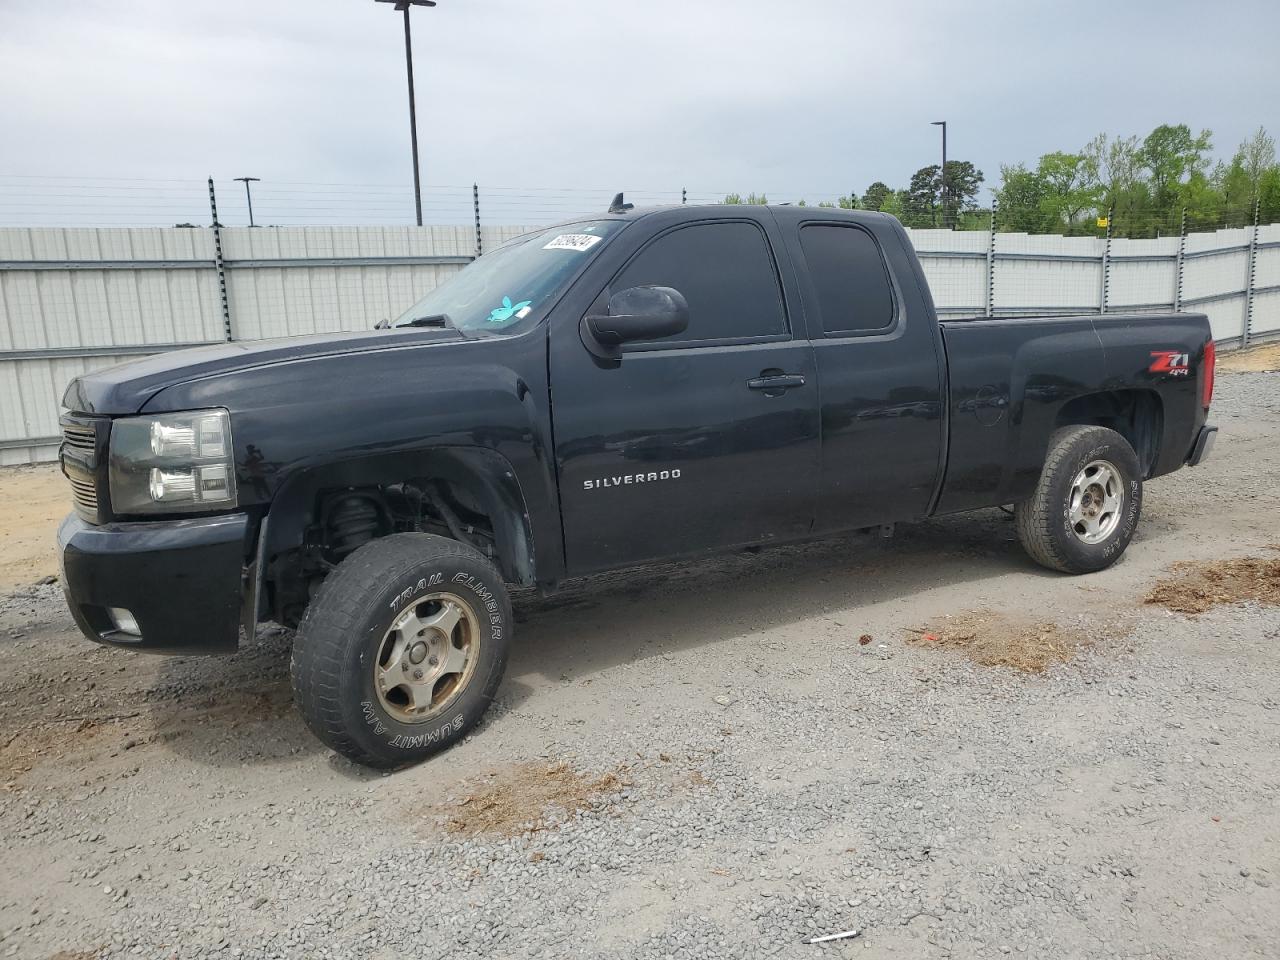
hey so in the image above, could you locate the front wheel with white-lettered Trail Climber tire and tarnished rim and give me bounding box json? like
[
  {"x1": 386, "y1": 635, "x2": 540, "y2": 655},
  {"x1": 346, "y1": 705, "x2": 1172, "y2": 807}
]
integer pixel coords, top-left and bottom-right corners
[{"x1": 291, "y1": 534, "x2": 512, "y2": 768}]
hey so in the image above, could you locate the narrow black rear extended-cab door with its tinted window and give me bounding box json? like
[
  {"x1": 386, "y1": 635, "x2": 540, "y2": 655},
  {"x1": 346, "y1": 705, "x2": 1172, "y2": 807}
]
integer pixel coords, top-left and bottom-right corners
[{"x1": 786, "y1": 220, "x2": 945, "y2": 532}]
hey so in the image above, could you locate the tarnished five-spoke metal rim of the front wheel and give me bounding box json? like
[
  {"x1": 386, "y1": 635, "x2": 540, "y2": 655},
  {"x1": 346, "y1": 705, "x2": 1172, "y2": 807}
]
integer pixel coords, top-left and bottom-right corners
[{"x1": 374, "y1": 593, "x2": 480, "y2": 723}]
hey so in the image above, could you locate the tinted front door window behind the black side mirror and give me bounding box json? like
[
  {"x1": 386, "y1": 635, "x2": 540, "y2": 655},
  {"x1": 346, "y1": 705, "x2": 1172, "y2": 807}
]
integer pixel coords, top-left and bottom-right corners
[{"x1": 609, "y1": 220, "x2": 787, "y2": 346}]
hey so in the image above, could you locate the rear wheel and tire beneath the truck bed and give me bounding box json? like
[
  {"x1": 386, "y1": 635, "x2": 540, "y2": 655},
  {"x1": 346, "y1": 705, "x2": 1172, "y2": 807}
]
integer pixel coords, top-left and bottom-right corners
[{"x1": 1014, "y1": 426, "x2": 1142, "y2": 573}]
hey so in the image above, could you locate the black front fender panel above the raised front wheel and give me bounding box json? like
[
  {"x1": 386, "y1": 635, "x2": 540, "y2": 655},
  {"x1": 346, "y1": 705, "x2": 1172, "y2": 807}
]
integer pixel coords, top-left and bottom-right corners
[{"x1": 137, "y1": 326, "x2": 563, "y2": 584}]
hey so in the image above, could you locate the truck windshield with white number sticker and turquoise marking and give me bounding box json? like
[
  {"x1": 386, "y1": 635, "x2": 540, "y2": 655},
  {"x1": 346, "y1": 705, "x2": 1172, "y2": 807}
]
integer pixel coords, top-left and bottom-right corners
[{"x1": 392, "y1": 220, "x2": 626, "y2": 334}]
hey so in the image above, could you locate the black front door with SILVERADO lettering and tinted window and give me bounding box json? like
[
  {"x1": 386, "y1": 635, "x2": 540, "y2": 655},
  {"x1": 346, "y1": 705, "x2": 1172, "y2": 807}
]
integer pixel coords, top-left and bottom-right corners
[{"x1": 550, "y1": 215, "x2": 818, "y2": 573}]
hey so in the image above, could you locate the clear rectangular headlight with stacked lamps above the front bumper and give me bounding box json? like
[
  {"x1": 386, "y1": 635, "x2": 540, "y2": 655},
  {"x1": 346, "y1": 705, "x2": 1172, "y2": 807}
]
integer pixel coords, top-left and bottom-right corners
[{"x1": 110, "y1": 410, "x2": 236, "y2": 513}]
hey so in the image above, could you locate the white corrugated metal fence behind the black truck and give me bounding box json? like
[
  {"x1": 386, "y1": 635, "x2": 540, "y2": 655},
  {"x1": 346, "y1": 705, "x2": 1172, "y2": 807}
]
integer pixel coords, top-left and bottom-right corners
[{"x1": 0, "y1": 224, "x2": 1280, "y2": 465}]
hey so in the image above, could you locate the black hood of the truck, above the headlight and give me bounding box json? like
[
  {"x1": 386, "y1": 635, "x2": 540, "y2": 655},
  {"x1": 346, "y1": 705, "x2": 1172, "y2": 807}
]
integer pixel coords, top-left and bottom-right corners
[{"x1": 63, "y1": 329, "x2": 463, "y2": 415}]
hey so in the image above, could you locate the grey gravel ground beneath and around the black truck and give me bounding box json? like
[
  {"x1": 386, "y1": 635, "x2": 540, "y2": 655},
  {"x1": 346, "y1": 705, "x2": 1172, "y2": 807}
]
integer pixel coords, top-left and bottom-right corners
[{"x1": 0, "y1": 374, "x2": 1280, "y2": 960}]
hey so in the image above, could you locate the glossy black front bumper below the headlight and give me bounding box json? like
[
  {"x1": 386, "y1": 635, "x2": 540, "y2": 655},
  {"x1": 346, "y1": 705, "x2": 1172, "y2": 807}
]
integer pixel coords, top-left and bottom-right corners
[{"x1": 58, "y1": 513, "x2": 250, "y2": 654}]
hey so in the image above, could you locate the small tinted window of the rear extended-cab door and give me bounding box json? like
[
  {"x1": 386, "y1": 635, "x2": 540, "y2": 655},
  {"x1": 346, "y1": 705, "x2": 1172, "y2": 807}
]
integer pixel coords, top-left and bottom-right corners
[{"x1": 800, "y1": 224, "x2": 895, "y2": 337}]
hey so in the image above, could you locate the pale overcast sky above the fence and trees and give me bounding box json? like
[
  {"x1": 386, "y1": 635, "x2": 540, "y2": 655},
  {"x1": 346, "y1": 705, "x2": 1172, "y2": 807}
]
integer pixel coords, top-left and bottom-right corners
[{"x1": 0, "y1": 0, "x2": 1280, "y2": 223}]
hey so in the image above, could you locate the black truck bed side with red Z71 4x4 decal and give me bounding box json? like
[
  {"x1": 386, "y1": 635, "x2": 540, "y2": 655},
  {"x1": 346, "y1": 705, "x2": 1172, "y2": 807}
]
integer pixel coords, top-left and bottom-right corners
[{"x1": 936, "y1": 314, "x2": 1211, "y2": 513}]
